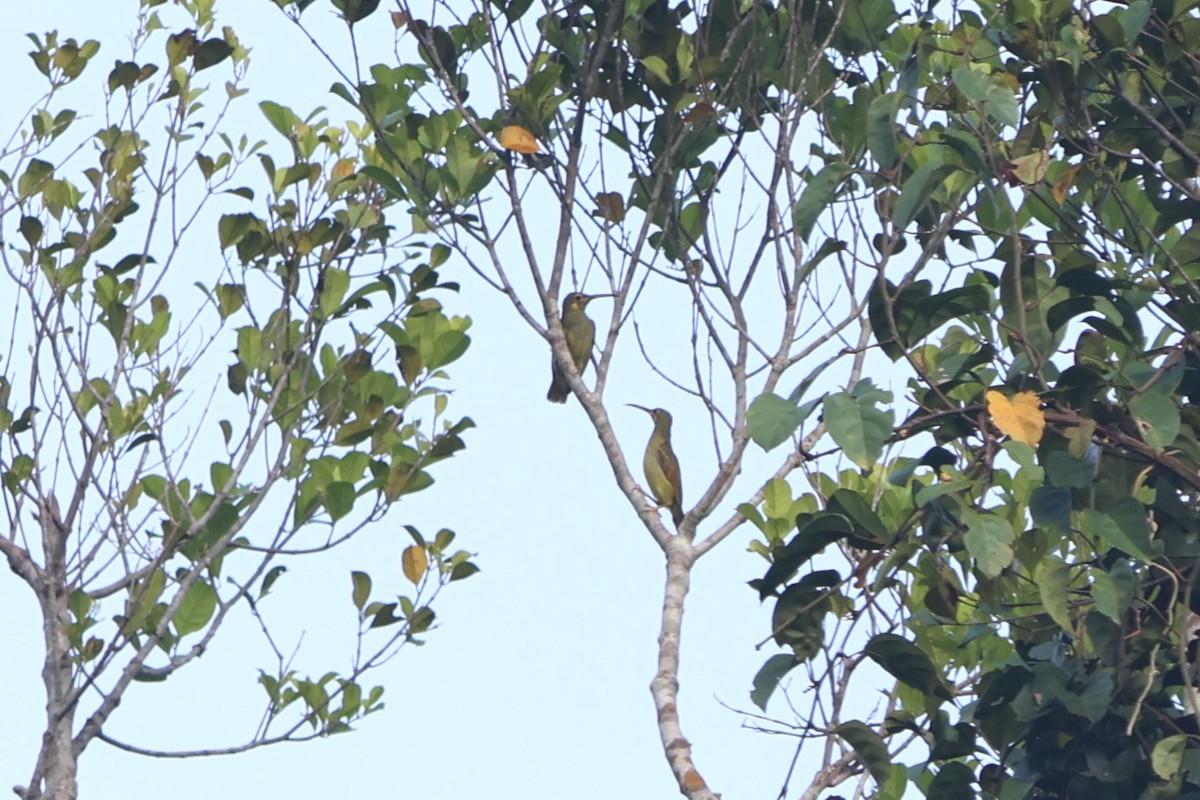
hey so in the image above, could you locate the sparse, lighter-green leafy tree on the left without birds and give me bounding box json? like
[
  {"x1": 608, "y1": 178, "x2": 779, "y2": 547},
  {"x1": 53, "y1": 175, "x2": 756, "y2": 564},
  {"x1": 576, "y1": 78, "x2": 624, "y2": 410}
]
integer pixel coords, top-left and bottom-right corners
[{"x1": 0, "y1": 0, "x2": 475, "y2": 800}]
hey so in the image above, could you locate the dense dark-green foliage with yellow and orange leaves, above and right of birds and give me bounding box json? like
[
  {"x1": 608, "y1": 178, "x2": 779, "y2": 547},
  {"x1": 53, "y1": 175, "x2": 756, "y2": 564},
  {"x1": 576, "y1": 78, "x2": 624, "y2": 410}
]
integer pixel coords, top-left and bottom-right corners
[{"x1": 280, "y1": 0, "x2": 1200, "y2": 799}]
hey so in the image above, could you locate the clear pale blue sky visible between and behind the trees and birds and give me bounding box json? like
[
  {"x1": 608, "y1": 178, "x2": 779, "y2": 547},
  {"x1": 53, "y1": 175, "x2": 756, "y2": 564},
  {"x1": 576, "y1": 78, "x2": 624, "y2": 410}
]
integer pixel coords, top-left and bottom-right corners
[{"x1": 0, "y1": 0, "x2": 830, "y2": 800}]
